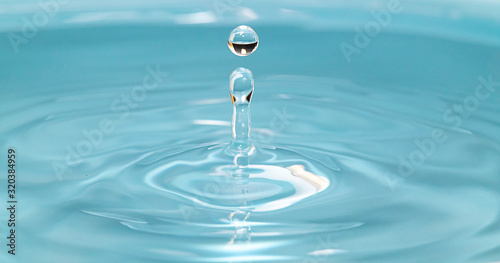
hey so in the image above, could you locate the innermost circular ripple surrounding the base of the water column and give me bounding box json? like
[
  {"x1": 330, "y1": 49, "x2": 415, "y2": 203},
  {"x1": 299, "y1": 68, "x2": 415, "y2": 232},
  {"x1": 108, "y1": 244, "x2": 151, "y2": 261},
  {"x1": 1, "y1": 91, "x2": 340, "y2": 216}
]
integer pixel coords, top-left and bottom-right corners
[{"x1": 146, "y1": 146, "x2": 333, "y2": 212}]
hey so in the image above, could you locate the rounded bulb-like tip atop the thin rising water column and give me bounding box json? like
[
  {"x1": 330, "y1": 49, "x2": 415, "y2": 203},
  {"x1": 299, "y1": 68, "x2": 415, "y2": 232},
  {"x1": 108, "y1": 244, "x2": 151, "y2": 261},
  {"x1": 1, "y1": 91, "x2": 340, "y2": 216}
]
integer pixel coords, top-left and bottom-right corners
[{"x1": 229, "y1": 68, "x2": 253, "y2": 104}]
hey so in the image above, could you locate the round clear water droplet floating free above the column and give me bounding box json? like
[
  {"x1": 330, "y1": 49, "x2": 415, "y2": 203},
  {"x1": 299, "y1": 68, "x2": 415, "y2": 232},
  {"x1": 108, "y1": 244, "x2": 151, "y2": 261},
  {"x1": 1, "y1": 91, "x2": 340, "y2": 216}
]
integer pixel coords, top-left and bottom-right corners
[{"x1": 227, "y1": 26, "x2": 259, "y2": 56}]
